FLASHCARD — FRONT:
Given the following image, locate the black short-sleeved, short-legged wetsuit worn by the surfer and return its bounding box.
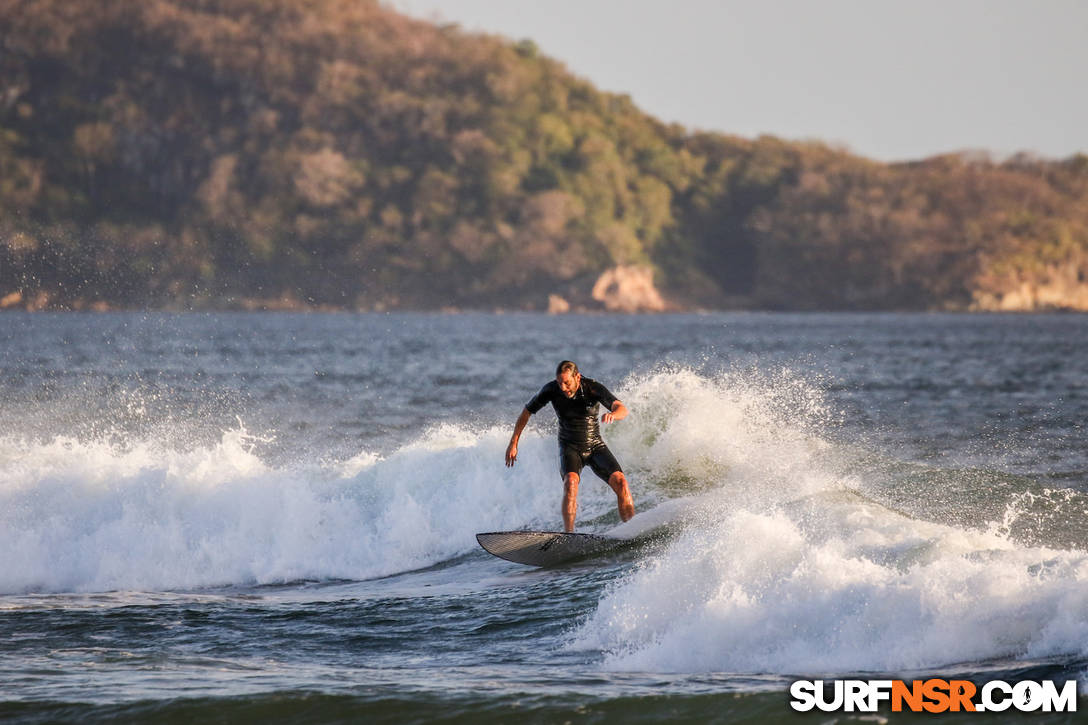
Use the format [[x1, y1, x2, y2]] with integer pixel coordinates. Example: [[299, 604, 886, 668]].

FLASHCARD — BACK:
[[526, 377, 623, 481]]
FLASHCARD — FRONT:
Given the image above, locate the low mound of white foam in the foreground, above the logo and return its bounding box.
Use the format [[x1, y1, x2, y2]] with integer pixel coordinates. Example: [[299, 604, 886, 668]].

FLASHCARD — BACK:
[[572, 474, 1088, 674]]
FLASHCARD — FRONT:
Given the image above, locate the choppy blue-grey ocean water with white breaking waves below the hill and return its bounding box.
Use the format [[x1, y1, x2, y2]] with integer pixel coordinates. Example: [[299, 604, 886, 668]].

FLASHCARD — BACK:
[[0, 312, 1088, 723]]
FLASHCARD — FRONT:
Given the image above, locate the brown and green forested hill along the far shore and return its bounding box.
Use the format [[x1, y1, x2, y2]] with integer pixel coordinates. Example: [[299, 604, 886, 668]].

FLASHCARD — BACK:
[[0, 0, 1088, 309]]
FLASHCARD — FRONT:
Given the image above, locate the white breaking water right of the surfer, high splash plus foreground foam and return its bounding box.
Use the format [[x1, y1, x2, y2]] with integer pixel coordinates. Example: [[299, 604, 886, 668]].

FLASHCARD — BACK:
[[569, 373, 1088, 675]]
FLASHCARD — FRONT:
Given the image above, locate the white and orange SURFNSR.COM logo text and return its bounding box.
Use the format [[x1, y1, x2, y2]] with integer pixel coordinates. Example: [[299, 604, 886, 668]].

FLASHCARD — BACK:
[[790, 679, 1077, 713]]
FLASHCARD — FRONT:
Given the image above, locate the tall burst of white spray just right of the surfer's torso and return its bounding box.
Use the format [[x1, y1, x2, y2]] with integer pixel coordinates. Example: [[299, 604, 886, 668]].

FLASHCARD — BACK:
[[607, 367, 844, 501]]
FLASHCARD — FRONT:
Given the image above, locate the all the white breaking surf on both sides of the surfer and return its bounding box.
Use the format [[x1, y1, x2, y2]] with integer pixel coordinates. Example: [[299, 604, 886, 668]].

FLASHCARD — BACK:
[[10, 354, 1088, 661]]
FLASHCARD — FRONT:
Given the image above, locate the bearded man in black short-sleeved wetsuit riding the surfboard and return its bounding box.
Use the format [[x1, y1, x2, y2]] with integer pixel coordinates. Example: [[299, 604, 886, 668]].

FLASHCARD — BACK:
[[506, 360, 634, 531]]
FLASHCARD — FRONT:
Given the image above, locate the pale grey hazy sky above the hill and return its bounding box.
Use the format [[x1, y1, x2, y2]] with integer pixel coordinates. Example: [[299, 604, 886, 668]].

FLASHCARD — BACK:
[[385, 0, 1088, 161]]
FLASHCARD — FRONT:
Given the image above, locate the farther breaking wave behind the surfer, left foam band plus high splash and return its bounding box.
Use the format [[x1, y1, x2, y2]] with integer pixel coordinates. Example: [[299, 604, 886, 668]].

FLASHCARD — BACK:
[[0, 369, 813, 593]]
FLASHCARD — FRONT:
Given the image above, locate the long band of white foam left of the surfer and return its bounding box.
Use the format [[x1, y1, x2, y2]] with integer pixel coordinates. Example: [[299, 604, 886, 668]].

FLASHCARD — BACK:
[[0, 418, 615, 593]]
